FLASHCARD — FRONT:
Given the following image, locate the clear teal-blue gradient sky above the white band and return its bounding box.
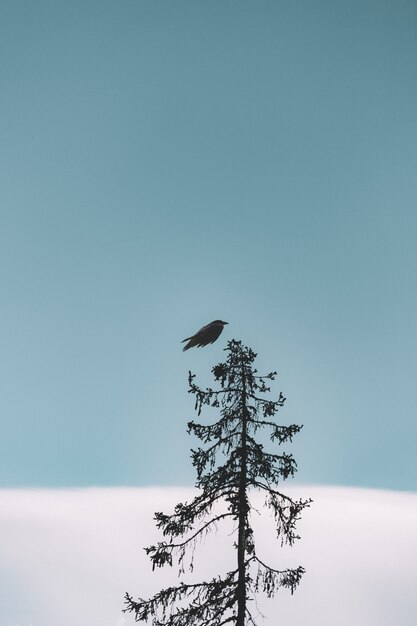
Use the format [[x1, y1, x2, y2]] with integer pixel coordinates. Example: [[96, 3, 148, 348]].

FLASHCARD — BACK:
[[0, 0, 417, 490]]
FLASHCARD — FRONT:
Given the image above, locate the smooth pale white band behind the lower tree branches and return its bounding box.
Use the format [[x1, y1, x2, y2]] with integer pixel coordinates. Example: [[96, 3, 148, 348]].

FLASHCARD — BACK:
[[0, 486, 417, 626]]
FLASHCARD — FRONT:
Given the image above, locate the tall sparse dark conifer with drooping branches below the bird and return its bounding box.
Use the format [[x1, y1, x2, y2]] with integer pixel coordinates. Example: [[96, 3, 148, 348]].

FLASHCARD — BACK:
[[125, 340, 311, 626]]
